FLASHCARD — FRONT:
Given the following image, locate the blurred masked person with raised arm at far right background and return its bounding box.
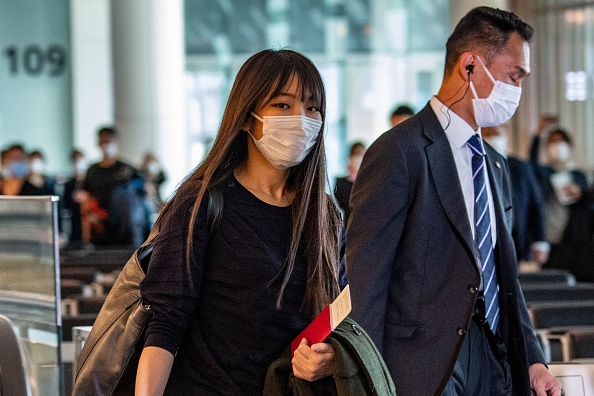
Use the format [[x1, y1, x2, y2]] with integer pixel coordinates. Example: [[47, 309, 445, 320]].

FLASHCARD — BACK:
[[530, 127, 594, 282]]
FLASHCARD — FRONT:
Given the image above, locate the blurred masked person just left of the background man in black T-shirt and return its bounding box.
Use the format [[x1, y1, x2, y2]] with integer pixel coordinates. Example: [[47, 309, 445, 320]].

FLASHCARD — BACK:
[[63, 149, 89, 248]]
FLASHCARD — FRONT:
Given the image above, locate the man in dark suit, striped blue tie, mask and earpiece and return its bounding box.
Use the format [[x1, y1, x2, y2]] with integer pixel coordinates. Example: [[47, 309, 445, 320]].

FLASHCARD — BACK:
[[347, 7, 560, 396]]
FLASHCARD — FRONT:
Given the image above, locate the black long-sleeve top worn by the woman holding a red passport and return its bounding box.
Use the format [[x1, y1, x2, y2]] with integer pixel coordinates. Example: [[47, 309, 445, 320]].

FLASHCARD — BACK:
[[141, 179, 346, 395]]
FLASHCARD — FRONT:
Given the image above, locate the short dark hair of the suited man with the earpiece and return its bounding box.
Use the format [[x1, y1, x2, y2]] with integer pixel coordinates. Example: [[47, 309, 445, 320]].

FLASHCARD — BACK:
[[445, 7, 534, 76]]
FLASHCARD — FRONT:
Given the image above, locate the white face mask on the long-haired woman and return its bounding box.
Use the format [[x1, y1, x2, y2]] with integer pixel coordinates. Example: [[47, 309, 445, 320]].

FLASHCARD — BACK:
[[248, 112, 322, 170]]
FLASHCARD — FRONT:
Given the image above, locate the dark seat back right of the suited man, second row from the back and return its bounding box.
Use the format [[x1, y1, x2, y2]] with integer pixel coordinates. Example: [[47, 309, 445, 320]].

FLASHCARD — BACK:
[[522, 283, 594, 305]]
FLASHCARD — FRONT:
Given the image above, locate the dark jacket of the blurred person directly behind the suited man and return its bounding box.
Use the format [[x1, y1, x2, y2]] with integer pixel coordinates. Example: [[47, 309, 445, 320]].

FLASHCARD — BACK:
[[507, 157, 547, 261]]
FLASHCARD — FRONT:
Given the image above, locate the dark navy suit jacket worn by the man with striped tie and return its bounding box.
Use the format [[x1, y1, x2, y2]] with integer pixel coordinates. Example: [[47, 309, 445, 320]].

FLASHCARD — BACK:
[[347, 105, 544, 396]]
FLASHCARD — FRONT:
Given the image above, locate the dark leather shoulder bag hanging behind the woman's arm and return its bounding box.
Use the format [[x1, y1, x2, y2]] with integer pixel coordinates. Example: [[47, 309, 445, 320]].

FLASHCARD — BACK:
[[72, 188, 223, 396]]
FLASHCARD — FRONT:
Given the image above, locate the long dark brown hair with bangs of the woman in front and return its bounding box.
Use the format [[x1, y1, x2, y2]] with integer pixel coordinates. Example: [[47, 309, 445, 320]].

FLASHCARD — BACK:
[[156, 49, 341, 318]]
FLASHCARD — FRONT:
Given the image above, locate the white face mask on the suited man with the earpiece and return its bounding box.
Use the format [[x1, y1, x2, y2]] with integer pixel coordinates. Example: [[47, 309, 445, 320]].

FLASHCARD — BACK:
[[470, 56, 522, 127]]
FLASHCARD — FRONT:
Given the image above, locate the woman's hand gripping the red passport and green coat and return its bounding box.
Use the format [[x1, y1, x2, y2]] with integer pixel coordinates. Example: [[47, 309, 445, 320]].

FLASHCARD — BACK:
[[292, 338, 334, 382]]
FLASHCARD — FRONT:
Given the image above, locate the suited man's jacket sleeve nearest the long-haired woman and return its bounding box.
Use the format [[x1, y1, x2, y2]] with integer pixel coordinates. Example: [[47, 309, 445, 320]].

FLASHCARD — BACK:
[[346, 132, 409, 351]]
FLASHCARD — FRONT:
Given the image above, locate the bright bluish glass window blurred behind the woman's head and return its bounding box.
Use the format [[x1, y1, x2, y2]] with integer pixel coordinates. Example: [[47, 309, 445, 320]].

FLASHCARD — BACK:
[[185, 0, 450, 180]]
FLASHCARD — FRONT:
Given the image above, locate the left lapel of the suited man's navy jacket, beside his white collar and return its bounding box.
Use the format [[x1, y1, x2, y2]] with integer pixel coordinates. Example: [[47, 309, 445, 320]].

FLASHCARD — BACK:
[[420, 106, 474, 251]]
